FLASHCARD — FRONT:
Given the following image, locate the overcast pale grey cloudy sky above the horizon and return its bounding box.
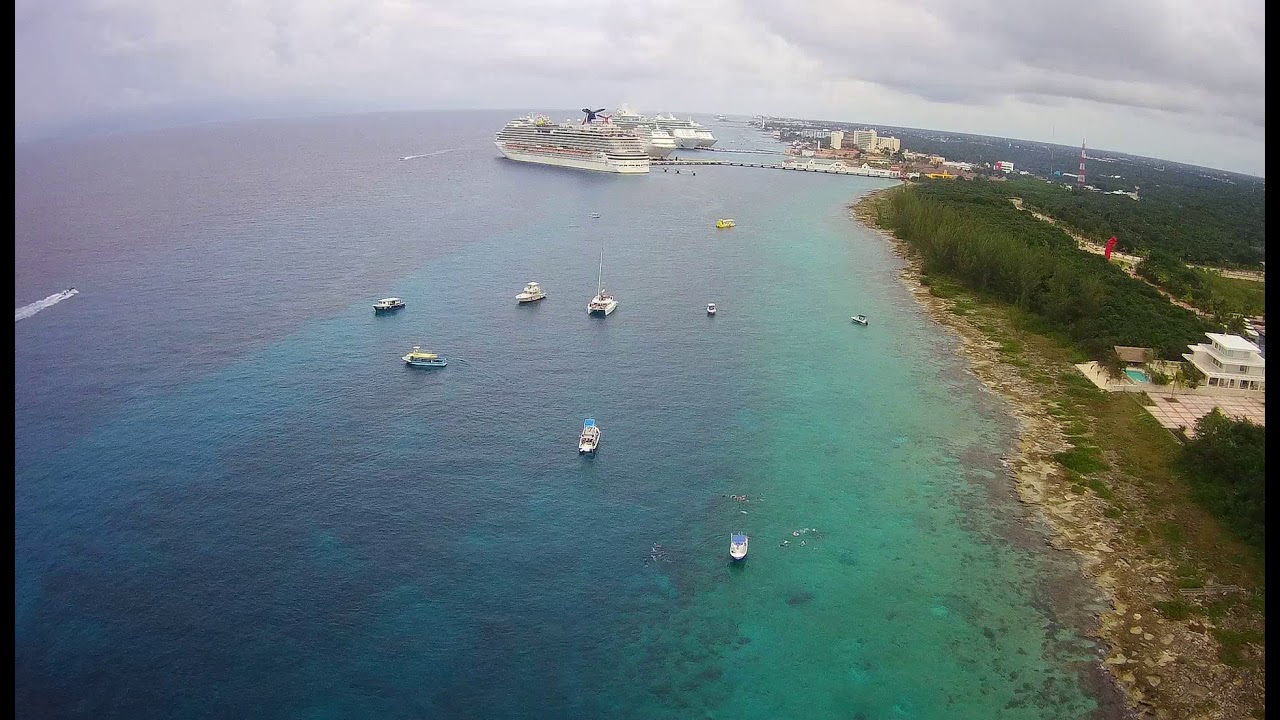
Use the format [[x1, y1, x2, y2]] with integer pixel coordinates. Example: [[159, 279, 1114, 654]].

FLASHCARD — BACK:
[[14, 0, 1266, 177]]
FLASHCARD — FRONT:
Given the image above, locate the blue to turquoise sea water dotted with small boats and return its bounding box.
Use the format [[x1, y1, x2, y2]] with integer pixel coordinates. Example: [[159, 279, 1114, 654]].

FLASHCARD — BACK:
[[14, 113, 1119, 720]]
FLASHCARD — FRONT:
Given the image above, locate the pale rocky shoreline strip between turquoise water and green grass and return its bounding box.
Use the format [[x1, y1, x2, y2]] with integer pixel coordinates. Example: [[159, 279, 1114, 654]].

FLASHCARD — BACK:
[[850, 188, 1265, 720]]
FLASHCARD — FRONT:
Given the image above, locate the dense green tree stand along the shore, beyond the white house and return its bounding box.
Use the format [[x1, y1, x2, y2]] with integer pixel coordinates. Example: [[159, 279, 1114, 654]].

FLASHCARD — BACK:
[[878, 181, 1220, 361]]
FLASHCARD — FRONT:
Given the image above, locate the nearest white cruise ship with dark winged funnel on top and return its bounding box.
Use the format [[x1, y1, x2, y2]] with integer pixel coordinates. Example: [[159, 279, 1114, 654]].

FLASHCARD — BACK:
[[494, 110, 649, 174]]
